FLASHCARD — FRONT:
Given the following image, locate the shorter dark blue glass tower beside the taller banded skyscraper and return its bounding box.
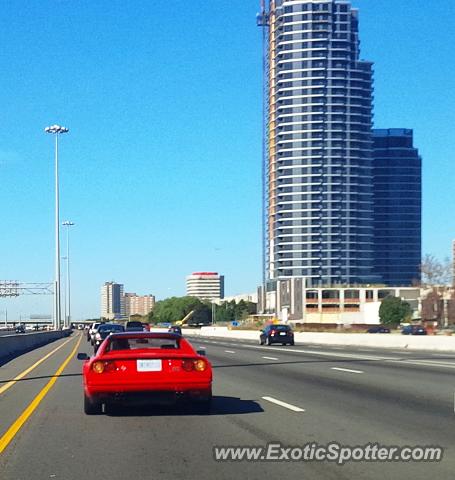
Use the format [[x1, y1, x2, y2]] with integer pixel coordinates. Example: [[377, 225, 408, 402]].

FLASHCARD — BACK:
[[373, 129, 422, 286]]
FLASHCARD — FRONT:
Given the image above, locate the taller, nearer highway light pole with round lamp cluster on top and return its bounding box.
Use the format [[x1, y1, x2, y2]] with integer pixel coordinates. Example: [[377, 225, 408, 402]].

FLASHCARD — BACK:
[[44, 125, 69, 330]]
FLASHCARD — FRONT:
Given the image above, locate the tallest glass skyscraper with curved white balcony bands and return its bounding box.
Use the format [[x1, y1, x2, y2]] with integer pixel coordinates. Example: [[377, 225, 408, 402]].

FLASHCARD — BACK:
[[258, 0, 380, 285]]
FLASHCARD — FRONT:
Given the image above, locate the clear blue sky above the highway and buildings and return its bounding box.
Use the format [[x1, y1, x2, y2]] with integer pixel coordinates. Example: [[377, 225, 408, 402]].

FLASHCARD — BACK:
[[0, 0, 455, 322]]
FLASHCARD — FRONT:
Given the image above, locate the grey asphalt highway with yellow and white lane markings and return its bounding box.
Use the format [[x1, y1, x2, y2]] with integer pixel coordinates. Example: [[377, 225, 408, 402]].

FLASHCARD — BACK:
[[0, 332, 455, 480]]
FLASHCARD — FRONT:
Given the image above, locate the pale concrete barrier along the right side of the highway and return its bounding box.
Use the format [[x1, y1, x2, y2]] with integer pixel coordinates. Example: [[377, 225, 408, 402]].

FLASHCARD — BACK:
[[183, 327, 455, 352]]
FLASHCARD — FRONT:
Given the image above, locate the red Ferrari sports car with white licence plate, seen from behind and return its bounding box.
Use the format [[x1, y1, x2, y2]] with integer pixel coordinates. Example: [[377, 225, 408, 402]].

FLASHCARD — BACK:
[[77, 332, 212, 415]]
